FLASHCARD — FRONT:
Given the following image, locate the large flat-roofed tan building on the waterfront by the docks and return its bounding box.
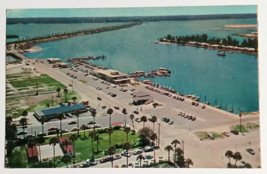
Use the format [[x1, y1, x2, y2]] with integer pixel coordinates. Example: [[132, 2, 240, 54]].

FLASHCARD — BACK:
[[91, 69, 131, 84]]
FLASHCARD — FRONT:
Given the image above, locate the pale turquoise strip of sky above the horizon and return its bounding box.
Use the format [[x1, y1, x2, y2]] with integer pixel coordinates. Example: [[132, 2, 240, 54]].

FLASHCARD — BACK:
[[6, 5, 257, 18]]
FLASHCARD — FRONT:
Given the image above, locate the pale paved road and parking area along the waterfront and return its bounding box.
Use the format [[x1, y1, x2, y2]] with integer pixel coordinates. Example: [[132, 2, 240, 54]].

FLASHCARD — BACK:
[[11, 52, 260, 168]]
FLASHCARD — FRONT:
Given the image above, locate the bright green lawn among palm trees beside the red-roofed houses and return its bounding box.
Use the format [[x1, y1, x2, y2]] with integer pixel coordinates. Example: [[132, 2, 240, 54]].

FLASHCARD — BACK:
[[45, 130, 138, 162]]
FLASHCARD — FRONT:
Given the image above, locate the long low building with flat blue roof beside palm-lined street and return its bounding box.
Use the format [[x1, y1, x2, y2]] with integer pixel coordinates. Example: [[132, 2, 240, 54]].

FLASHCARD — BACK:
[[33, 103, 87, 121]]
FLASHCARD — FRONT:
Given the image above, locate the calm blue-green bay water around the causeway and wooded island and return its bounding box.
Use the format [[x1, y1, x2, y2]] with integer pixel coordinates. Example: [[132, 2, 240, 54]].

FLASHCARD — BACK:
[[7, 19, 259, 113]]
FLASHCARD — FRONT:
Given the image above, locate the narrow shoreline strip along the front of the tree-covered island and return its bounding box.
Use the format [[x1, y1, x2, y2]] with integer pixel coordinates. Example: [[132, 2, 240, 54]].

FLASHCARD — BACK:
[[154, 41, 258, 56]]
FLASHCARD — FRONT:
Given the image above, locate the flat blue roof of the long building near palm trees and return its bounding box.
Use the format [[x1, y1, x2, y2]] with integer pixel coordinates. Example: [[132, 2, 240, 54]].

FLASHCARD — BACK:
[[34, 103, 86, 116]]
